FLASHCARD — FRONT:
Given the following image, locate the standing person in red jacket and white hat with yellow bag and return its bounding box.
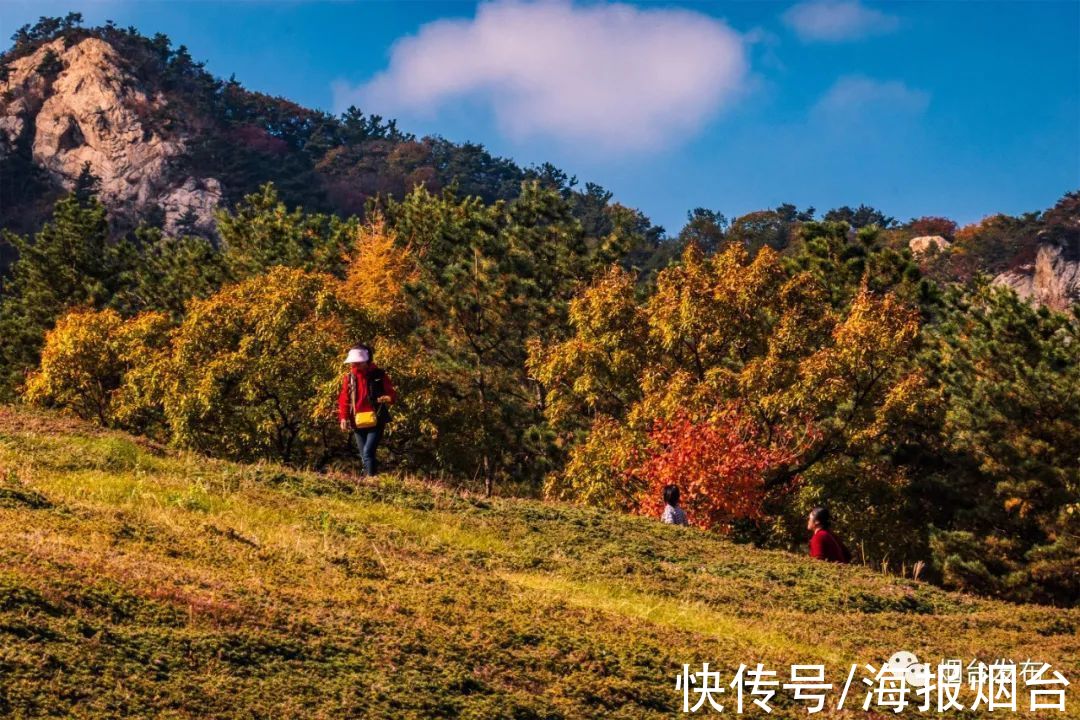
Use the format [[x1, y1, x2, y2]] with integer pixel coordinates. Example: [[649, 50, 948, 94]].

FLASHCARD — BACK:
[[338, 345, 397, 477]]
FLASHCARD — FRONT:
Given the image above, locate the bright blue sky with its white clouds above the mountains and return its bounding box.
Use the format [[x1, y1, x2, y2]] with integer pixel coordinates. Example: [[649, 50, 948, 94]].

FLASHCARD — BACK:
[[0, 0, 1080, 232]]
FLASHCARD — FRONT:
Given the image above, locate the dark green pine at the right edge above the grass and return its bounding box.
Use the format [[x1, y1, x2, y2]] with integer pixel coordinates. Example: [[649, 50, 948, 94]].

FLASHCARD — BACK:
[[927, 283, 1080, 603]]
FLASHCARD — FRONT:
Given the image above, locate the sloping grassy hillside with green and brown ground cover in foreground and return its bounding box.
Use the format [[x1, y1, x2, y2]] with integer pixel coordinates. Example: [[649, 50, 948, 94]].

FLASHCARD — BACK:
[[0, 408, 1080, 718]]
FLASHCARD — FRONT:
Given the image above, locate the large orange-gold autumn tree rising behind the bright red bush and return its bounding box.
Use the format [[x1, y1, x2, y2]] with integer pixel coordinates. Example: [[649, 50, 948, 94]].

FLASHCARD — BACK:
[[529, 235, 923, 557]]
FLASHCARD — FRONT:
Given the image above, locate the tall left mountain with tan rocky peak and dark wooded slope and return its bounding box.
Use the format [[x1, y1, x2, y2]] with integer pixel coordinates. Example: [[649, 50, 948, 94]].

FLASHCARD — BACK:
[[0, 15, 662, 245]]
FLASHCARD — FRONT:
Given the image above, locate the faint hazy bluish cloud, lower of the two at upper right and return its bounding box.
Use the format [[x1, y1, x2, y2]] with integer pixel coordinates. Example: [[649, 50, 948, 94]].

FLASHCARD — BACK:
[[810, 76, 930, 123]]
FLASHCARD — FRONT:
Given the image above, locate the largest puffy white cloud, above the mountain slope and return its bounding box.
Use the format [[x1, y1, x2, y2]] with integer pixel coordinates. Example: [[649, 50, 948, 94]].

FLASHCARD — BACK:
[[334, 0, 748, 150]]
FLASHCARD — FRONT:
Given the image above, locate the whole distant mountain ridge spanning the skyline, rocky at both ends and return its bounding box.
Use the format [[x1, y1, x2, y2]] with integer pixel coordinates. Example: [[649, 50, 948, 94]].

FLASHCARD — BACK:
[[0, 13, 1080, 309]]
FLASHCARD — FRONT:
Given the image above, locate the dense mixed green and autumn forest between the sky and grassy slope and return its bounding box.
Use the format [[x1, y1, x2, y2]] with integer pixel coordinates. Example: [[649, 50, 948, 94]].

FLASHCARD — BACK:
[[0, 17, 1080, 604]]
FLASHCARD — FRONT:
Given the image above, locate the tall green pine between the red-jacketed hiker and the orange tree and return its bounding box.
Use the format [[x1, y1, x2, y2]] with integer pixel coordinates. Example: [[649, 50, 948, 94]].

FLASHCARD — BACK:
[[387, 181, 635, 490]]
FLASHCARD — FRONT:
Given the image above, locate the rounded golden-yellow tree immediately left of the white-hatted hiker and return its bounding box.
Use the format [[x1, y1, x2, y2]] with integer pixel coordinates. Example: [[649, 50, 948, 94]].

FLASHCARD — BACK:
[[162, 268, 372, 464]]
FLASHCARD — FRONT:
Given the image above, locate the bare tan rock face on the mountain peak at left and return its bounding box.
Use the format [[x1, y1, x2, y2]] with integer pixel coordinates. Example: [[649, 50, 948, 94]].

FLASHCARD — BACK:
[[0, 37, 221, 234]]
